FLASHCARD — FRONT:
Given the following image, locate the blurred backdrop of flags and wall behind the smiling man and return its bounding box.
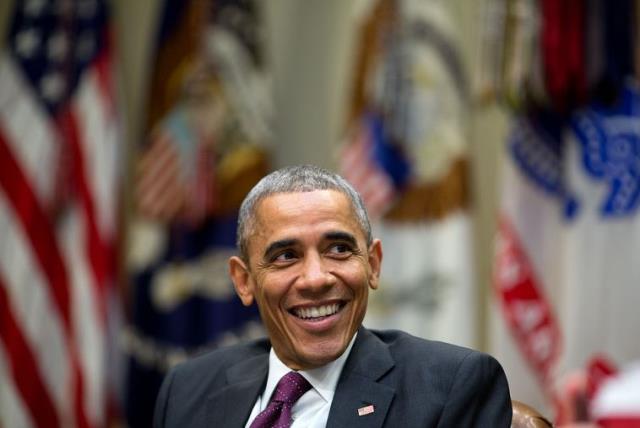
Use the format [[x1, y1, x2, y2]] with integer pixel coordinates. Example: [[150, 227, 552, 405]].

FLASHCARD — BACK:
[[0, 0, 640, 428]]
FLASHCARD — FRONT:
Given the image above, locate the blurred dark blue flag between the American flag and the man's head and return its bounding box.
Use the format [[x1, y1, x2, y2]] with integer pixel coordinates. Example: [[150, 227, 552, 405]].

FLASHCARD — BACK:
[[123, 0, 270, 427]]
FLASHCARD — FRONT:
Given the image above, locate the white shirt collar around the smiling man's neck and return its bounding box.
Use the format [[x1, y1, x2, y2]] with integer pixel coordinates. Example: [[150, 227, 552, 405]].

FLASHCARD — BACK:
[[262, 331, 358, 403]]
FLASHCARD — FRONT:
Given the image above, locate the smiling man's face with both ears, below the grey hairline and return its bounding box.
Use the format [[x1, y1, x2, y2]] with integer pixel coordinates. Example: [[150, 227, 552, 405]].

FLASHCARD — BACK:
[[229, 190, 382, 370]]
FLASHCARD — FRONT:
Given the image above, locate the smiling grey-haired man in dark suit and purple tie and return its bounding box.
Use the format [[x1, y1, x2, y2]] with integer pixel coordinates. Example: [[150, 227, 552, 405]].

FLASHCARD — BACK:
[[155, 166, 511, 428]]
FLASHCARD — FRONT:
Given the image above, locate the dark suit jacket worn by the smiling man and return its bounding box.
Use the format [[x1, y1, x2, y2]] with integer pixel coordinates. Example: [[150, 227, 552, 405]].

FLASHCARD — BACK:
[[154, 328, 511, 428]]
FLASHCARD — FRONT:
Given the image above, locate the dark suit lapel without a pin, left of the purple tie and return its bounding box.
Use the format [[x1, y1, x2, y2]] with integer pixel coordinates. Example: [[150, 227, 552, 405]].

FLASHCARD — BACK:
[[207, 353, 269, 427]]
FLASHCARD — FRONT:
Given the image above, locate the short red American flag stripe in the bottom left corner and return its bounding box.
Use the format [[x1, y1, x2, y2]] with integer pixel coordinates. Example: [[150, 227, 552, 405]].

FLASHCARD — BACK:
[[0, 278, 60, 427]]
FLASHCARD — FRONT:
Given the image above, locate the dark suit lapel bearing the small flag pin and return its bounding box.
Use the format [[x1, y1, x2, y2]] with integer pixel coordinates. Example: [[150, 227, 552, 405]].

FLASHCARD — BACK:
[[327, 328, 395, 428]]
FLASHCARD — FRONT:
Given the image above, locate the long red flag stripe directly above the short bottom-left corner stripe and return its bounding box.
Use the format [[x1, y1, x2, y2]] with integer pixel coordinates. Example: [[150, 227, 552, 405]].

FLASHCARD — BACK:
[[0, 132, 89, 428]]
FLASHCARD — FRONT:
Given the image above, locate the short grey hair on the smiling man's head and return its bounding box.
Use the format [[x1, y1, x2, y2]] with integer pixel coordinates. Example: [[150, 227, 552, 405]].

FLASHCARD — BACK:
[[236, 165, 373, 261]]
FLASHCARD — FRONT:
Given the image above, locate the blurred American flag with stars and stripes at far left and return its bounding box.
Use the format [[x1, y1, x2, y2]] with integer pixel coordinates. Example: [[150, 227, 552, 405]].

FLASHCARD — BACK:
[[0, 0, 119, 427]]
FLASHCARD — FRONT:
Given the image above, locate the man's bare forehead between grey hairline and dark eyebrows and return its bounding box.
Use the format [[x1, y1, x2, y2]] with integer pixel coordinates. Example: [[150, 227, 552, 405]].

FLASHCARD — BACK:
[[254, 190, 364, 238]]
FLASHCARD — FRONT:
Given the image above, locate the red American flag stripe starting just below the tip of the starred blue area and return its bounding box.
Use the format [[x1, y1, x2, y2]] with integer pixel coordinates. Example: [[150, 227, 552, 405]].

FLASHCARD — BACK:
[[58, 109, 110, 328]]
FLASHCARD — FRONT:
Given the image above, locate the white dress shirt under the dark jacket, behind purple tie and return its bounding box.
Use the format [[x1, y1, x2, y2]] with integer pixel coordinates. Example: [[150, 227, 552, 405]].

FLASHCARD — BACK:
[[245, 332, 358, 428]]
